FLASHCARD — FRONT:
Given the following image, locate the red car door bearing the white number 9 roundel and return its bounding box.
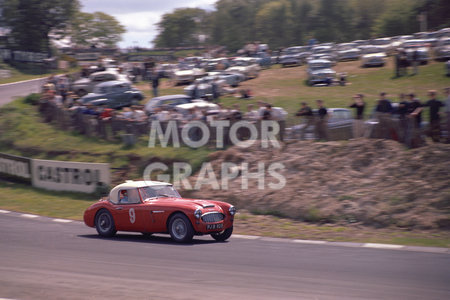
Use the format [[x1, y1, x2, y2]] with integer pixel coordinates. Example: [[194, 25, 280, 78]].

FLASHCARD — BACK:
[[114, 188, 151, 232]]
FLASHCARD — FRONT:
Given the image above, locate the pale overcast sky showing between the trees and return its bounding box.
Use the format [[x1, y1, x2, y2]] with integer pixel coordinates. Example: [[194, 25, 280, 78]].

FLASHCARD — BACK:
[[80, 0, 217, 48]]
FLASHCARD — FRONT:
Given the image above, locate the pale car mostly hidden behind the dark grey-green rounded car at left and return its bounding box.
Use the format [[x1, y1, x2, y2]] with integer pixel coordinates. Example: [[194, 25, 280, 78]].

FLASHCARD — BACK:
[[71, 71, 131, 97]]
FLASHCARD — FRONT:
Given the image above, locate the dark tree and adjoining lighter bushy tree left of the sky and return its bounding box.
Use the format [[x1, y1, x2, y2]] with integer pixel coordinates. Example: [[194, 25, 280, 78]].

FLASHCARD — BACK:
[[0, 0, 125, 54]]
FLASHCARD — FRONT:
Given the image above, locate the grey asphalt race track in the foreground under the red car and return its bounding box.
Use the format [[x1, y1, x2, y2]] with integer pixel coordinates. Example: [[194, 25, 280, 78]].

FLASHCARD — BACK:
[[0, 211, 450, 299]]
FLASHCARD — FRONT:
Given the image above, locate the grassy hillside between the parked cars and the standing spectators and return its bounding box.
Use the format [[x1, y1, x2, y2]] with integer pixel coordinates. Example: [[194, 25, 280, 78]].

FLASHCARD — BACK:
[[139, 58, 450, 123]]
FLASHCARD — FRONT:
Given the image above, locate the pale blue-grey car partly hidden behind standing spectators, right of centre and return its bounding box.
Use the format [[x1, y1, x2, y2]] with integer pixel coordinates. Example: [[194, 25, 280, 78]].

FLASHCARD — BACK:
[[286, 108, 354, 140]]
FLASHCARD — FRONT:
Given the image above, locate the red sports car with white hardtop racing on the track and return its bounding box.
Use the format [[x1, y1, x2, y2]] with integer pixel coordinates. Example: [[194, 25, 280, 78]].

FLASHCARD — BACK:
[[84, 180, 236, 242]]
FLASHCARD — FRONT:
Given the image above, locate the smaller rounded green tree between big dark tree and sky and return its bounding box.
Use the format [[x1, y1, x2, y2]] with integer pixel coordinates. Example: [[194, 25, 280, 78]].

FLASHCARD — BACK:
[[69, 12, 125, 47]]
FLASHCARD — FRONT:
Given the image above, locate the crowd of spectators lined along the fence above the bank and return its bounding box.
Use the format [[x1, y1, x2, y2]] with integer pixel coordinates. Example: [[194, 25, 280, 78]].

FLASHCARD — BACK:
[[40, 69, 450, 148]]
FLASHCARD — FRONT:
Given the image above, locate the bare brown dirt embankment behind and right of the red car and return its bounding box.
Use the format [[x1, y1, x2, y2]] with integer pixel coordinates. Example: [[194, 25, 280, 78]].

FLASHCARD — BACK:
[[185, 139, 450, 230]]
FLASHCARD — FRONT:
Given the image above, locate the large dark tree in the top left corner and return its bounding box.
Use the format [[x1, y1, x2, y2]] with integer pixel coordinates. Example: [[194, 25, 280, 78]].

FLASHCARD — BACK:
[[2, 0, 80, 52]]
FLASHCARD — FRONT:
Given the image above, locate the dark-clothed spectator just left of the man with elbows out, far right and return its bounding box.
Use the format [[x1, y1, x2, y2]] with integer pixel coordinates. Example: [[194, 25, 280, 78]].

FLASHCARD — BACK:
[[405, 93, 423, 148]]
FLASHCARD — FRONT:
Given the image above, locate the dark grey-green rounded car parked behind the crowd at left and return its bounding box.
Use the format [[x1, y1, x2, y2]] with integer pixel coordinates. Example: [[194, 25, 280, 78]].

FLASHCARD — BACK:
[[80, 80, 144, 108]]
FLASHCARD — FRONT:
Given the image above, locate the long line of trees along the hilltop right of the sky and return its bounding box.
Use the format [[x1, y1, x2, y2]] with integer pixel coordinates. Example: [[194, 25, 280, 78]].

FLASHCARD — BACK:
[[153, 0, 450, 51]]
